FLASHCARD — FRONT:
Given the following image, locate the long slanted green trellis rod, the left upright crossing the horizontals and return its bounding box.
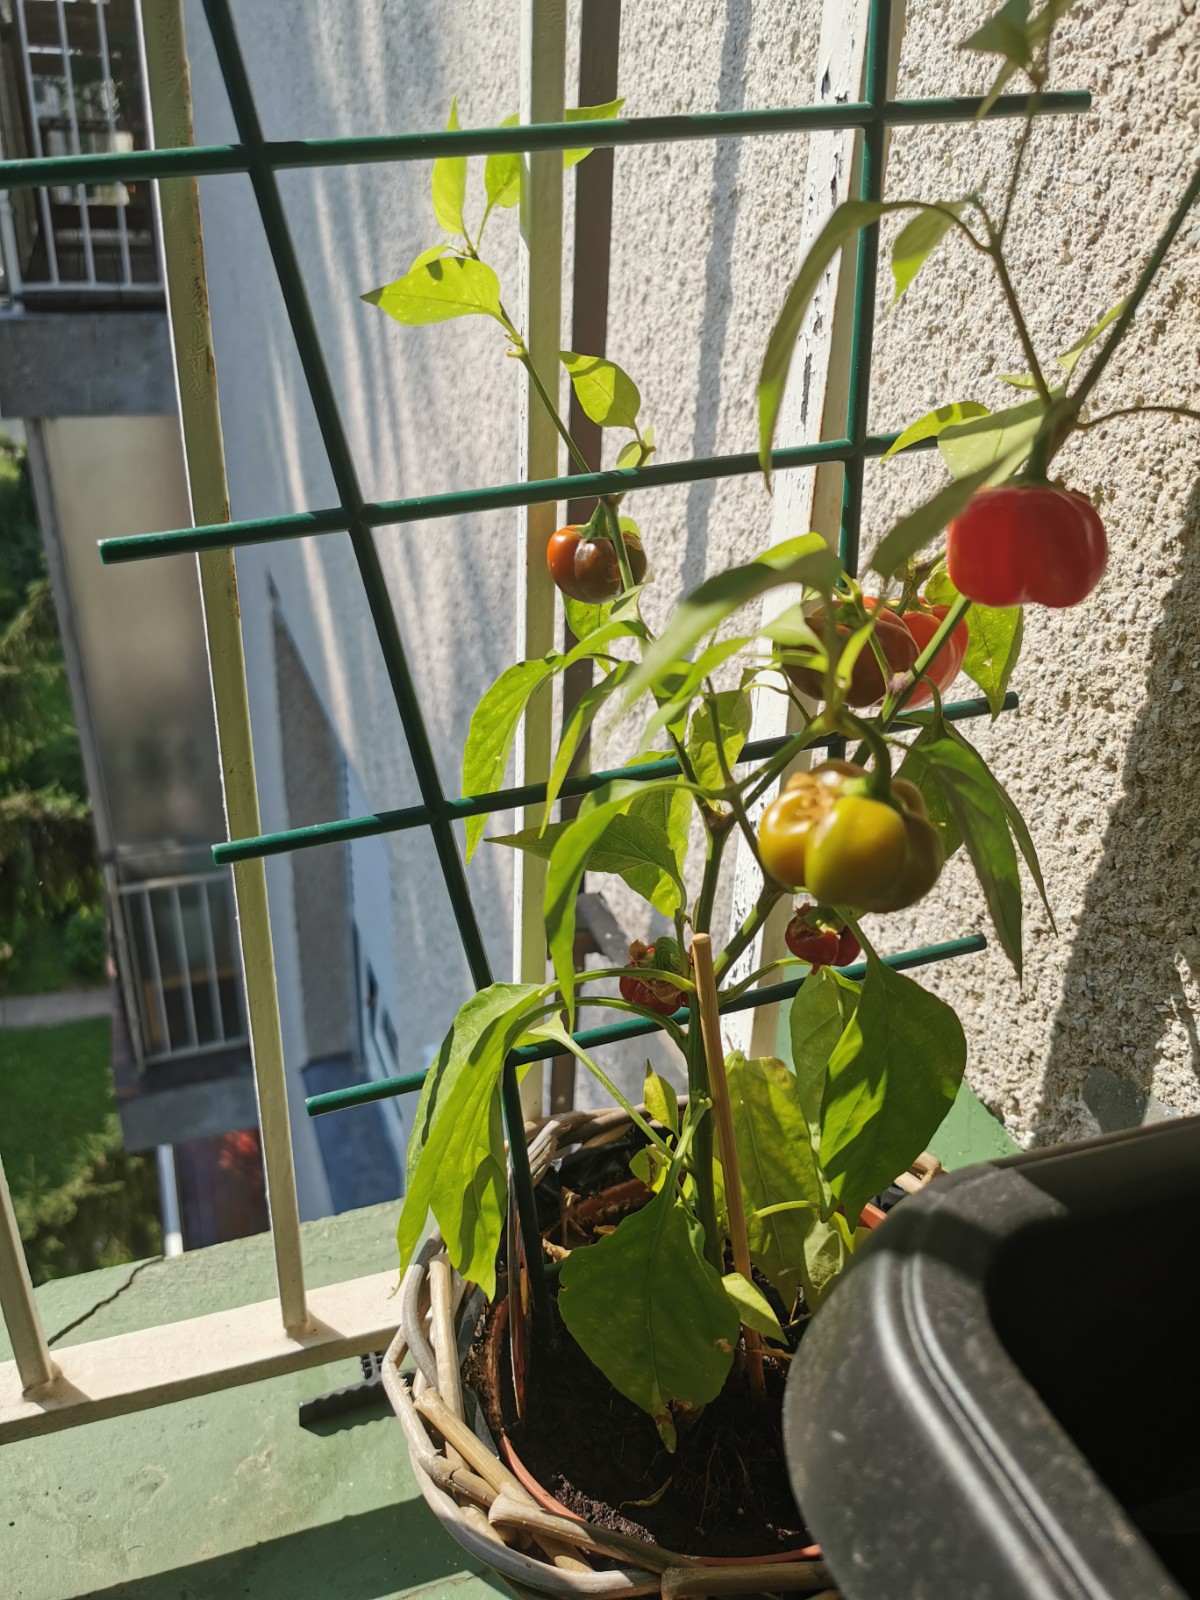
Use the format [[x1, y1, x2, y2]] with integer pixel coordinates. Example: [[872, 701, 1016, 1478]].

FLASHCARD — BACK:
[[203, 0, 491, 989]]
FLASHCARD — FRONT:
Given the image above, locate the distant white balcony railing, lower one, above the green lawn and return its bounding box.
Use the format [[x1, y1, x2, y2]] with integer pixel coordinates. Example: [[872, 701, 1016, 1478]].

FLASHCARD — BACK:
[[117, 872, 248, 1066]]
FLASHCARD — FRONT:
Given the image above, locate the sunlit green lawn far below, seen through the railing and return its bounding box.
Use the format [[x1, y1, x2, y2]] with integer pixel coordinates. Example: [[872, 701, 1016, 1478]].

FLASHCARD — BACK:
[[0, 1018, 162, 1283]]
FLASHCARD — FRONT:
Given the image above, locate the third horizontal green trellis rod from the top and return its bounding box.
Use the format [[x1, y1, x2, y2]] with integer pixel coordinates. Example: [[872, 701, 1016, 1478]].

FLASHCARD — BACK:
[[213, 690, 1019, 867]]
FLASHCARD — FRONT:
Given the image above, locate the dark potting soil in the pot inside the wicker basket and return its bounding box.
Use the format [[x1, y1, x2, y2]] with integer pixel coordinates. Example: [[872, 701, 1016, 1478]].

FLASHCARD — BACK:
[[502, 1306, 811, 1557]]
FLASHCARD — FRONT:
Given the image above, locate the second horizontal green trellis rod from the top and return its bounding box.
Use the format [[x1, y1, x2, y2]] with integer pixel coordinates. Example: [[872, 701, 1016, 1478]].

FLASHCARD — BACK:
[[99, 432, 938, 566]]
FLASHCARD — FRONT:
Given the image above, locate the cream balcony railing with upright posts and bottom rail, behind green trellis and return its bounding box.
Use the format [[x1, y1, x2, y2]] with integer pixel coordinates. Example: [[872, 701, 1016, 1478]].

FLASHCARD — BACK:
[[0, 0, 883, 1443]]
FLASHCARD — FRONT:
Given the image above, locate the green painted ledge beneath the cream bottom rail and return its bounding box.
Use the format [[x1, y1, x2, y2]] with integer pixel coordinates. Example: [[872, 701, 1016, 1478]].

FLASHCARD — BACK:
[[0, 1205, 507, 1600]]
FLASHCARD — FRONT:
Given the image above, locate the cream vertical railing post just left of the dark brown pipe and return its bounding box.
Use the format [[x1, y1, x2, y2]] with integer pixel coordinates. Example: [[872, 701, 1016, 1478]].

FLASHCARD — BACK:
[[512, 0, 566, 1117]]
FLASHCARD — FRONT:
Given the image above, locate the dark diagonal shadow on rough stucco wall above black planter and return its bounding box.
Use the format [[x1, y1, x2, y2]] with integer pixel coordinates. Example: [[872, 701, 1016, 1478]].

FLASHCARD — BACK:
[[1035, 467, 1200, 1144]]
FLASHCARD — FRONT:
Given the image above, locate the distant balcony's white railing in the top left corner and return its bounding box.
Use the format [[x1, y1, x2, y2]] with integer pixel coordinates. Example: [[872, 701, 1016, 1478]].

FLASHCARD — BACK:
[[0, 0, 163, 310]]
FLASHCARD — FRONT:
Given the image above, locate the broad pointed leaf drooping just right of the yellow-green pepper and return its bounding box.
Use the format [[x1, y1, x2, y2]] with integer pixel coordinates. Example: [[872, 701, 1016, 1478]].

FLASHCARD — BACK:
[[906, 736, 1021, 978]]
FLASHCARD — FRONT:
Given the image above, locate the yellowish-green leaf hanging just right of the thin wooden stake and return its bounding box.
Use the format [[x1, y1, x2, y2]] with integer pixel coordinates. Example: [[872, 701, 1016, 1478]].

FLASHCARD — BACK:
[[726, 1051, 824, 1306]]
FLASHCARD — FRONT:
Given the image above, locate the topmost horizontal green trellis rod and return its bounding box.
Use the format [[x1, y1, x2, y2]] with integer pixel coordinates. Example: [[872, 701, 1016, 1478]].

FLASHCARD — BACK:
[[0, 90, 1091, 189]]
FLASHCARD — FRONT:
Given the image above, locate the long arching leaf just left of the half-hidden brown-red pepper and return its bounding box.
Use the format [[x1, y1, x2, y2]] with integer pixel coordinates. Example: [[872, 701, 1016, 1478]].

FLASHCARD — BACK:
[[626, 533, 842, 707]]
